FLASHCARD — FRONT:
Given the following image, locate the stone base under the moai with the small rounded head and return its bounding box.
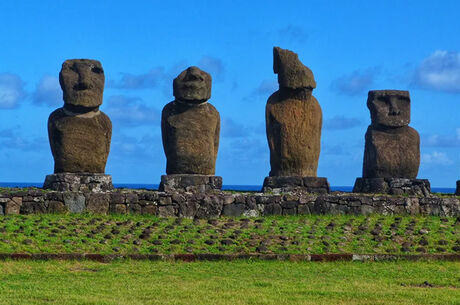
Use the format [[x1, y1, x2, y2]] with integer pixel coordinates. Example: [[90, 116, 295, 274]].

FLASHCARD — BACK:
[[159, 174, 222, 193]]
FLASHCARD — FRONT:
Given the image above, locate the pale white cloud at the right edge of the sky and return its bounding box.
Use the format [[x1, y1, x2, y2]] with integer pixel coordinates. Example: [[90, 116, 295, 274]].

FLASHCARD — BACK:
[[413, 50, 460, 93]]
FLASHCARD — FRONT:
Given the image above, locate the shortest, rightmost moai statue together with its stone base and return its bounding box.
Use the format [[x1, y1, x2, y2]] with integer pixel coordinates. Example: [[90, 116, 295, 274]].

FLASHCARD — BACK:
[[353, 90, 430, 195]]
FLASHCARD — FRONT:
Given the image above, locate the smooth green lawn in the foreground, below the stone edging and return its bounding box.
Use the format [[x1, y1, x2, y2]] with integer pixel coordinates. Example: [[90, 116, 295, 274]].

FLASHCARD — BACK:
[[0, 260, 460, 305]]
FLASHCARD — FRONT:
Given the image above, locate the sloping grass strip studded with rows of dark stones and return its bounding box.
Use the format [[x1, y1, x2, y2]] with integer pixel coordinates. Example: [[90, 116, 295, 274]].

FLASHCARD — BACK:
[[0, 214, 460, 254]]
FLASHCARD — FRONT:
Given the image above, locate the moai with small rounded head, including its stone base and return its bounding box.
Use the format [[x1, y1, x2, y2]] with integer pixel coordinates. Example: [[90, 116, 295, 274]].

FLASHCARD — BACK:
[[160, 67, 222, 192]]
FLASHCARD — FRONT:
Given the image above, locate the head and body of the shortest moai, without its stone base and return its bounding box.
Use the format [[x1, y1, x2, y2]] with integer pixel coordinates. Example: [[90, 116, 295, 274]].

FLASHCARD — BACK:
[[363, 90, 420, 179]]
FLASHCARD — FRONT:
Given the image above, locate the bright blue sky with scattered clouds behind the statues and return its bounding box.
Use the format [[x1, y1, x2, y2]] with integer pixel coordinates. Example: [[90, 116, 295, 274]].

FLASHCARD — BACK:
[[0, 0, 460, 187]]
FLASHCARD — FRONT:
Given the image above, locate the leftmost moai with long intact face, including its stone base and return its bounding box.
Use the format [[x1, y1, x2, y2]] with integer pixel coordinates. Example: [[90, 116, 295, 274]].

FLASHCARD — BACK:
[[44, 59, 113, 192]]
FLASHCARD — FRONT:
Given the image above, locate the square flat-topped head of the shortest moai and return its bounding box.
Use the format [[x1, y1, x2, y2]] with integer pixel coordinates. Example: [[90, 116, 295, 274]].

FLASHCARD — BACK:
[[367, 90, 410, 127]]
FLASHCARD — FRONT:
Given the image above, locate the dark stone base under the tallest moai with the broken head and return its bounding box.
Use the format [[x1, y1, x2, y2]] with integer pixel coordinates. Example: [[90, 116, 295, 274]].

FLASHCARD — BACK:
[[262, 176, 330, 194]]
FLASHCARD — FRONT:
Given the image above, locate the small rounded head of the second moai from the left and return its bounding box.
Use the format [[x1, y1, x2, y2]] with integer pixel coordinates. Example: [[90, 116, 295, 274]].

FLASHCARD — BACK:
[[173, 67, 212, 104]]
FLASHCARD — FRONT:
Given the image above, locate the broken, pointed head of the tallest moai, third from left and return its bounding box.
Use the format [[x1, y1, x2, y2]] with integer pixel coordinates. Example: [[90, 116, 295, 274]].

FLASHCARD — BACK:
[[273, 47, 316, 90]]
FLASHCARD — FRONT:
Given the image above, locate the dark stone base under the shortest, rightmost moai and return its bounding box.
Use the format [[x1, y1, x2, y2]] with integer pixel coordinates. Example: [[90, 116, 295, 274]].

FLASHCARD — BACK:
[[353, 178, 431, 196]]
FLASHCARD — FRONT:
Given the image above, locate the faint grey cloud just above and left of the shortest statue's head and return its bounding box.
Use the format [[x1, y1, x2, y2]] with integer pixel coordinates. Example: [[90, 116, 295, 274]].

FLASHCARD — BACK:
[[330, 68, 380, 96]]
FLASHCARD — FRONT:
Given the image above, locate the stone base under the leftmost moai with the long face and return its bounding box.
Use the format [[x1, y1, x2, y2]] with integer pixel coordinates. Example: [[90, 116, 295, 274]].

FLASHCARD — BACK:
[[43, 173, 113, 193]]
